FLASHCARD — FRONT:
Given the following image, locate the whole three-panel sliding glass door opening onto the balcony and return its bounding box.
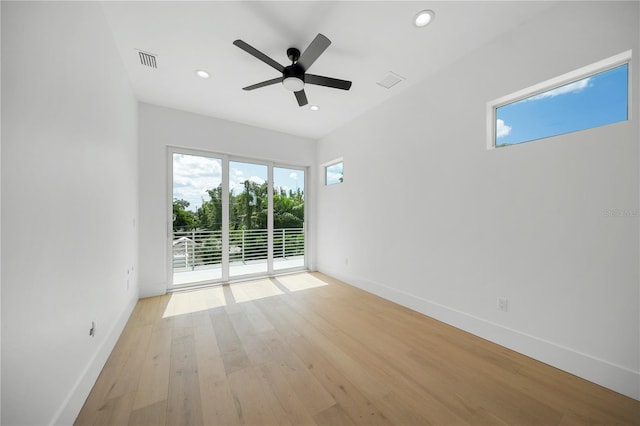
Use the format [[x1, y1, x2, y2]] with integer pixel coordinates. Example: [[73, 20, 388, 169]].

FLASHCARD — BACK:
[[169, 149, 306, 288]]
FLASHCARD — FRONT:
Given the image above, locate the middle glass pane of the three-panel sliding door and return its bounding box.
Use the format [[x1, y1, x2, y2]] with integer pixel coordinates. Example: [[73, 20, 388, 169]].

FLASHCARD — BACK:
[[229, 161, 269, 277]]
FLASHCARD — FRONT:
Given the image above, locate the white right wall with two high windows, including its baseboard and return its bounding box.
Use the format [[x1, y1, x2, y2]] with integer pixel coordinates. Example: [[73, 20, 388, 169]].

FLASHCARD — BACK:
[[317, 2, 640, 398]]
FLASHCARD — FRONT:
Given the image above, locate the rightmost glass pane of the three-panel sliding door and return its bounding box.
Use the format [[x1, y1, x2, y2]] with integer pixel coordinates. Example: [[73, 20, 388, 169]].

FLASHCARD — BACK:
[[273, 167, 304, 270]]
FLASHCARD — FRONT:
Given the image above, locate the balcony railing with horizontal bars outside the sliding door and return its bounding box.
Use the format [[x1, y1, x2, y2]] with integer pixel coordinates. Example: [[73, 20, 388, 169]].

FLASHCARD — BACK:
[[173, 228, 304, 269]]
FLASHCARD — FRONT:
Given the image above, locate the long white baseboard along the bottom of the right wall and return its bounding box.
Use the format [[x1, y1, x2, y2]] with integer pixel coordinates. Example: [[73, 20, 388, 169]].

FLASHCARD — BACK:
[[318, 265, 640, 400]]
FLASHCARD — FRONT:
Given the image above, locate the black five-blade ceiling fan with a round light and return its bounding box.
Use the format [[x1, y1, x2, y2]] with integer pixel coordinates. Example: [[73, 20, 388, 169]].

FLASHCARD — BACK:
[[233, 34, 351, 106]]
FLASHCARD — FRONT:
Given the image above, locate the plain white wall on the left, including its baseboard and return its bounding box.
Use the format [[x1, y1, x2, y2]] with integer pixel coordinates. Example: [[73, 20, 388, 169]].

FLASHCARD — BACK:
[[1, 1, 138, 425]]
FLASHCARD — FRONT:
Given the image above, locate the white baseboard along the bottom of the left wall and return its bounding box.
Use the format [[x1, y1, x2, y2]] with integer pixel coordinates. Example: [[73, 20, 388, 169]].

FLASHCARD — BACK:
[[50, 299, 138, 426]]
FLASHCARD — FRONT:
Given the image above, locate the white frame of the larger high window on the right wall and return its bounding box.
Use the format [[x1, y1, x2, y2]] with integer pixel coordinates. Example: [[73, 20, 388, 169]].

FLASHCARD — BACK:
[[486, 50, 633, 150]]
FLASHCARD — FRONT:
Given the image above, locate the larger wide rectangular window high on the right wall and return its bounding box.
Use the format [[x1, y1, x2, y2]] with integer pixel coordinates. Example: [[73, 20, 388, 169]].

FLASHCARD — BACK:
[[488, 51, 631, 148]]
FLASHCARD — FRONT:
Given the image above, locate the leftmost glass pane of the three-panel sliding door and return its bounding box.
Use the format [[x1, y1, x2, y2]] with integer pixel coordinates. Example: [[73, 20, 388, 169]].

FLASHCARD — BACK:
[[172, 153, 222, 285]]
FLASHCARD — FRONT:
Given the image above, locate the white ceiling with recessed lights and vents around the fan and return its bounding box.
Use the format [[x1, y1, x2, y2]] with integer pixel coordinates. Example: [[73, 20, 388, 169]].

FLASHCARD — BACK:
[[103, 1, 553, 139]]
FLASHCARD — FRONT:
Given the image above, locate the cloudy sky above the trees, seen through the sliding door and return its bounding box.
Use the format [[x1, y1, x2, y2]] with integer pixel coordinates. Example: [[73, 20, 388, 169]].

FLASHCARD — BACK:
[[173, 154, 304, 212]]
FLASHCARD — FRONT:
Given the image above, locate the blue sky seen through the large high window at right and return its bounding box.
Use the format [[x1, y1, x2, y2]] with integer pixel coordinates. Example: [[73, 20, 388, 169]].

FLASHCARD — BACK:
[[496, 64, 628, 146]]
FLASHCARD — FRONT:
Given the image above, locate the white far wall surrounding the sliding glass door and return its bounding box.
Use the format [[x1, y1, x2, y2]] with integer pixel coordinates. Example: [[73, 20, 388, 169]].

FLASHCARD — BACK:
[[139, 103, 317, 297]]
